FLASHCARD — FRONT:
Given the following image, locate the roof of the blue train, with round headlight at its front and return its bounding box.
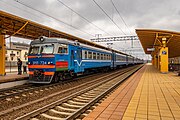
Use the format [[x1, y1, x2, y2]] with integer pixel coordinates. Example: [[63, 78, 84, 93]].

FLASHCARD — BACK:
[[31, 37, 130, 56]]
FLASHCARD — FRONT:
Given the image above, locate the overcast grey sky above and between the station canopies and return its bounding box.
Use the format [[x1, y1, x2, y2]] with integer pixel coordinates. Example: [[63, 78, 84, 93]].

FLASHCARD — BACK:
[[0, 0, 180, 59]]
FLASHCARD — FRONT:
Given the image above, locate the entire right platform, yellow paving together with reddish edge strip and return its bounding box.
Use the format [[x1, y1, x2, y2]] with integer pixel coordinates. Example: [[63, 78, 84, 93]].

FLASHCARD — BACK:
[[83, 64, 180, 120]]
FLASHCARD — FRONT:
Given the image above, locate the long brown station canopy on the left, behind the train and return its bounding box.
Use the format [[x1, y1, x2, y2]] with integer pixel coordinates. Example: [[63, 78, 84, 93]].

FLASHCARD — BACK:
[[0, 10, 127, 55]]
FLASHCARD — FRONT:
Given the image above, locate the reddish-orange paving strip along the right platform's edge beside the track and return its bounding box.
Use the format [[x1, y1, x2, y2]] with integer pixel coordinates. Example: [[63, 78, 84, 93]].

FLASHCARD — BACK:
[[83, 66, 146, 120]]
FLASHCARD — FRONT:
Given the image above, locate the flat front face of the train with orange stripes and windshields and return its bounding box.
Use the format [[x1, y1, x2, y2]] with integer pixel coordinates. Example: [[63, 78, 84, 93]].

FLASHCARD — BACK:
[[28, 44, 55, 83]]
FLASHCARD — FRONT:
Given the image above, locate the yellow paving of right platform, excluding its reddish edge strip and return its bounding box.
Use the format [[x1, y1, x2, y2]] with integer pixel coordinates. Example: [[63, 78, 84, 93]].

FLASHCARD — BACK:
[[123, 65, 180, 120]]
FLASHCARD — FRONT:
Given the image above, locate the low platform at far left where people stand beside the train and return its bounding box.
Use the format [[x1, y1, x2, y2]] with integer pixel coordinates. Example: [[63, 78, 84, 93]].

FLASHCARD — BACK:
[[0, 72, 28, 84]]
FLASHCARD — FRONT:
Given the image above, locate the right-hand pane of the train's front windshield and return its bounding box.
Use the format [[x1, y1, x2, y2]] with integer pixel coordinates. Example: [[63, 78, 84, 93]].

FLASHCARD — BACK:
[[40, 44, 54, 54]]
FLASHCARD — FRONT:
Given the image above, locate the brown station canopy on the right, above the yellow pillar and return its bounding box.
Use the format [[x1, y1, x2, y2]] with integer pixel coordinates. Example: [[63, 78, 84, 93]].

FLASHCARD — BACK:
[[136, 29, 180, 58]]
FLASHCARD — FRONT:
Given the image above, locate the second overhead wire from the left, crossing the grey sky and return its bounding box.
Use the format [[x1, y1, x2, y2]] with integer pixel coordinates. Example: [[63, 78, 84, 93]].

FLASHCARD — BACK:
[[57, 0, 112, 36]]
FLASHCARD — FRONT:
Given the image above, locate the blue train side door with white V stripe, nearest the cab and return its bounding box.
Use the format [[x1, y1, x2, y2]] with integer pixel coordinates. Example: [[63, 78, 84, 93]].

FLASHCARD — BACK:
[[74, 47, 82, 72]]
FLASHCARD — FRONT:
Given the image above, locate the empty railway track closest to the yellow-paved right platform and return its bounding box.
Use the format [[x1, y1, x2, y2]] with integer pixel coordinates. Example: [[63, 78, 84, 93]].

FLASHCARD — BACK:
[[16, 66, 142, 120]]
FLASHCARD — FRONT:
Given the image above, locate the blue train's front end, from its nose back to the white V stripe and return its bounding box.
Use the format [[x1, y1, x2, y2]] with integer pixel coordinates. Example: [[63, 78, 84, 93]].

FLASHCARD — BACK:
[[28, 39, 83, 84]]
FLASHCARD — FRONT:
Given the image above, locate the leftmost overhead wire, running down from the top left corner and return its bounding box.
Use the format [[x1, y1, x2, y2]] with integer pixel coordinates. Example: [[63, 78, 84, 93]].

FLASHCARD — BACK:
[[14, 0, 94, 37]]
